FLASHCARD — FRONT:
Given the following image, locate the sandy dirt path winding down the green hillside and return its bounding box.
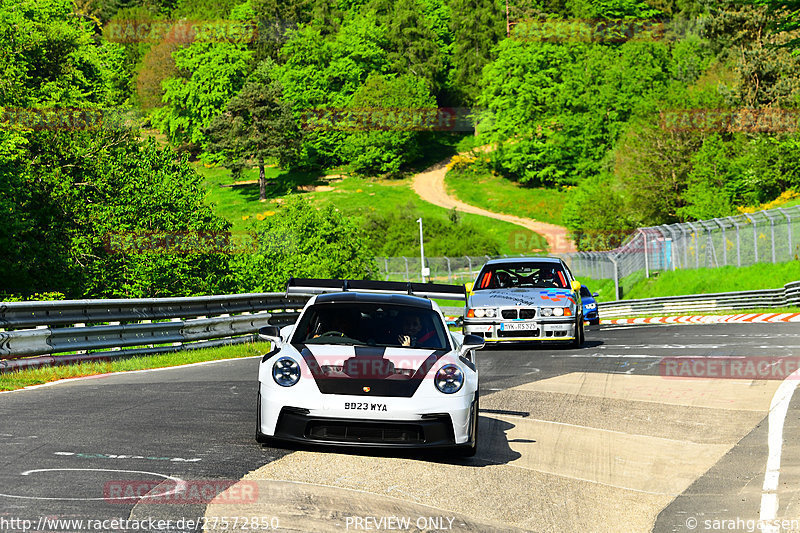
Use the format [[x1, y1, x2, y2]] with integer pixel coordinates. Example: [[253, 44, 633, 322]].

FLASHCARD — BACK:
[[412, 159, 577, 254]]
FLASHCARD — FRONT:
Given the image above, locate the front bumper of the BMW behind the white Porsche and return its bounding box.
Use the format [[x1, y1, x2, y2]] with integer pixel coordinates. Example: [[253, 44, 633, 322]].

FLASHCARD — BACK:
[[464, 318, 576, 343]]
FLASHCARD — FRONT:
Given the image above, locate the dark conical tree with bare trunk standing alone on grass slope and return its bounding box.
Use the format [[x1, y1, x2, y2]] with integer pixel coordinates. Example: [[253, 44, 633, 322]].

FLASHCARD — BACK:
[[208, 62, 300, 200]]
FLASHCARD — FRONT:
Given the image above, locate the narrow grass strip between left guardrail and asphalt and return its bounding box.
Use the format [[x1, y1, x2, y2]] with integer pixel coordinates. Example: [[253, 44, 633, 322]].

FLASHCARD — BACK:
[[0, 342, 269, 390]]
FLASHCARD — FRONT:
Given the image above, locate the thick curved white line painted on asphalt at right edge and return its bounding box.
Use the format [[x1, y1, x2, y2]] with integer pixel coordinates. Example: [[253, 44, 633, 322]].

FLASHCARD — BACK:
[[759, 370, 800, 533]]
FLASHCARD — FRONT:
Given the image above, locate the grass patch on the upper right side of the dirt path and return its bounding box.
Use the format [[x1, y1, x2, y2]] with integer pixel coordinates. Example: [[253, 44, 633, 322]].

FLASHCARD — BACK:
[[445, 170, 568, 225]]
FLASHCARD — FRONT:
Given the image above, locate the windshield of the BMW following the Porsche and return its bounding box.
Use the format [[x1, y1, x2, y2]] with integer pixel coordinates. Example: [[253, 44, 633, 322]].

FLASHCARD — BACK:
[[473, 263, 569, 291]]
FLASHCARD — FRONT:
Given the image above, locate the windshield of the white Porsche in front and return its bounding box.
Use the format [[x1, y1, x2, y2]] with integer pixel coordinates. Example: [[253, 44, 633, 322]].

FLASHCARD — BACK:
[[292, 302, 449, 350]]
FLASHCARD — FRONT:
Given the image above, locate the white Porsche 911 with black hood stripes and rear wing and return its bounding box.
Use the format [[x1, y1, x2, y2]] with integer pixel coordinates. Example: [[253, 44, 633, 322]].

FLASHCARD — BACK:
[[256, 279, 484, 456]]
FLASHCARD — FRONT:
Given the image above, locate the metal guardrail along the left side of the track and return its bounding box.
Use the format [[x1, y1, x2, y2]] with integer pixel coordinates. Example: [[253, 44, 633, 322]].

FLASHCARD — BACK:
[[0, 293, 309, 372]]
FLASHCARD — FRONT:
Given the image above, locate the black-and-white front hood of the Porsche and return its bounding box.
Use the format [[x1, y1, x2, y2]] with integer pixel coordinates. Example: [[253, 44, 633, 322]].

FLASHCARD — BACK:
[[293, 344, 450, 398]]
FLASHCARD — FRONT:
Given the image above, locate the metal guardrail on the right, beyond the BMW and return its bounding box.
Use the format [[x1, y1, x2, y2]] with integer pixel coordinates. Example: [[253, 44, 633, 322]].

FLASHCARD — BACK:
[[597, 281, 800, 318]]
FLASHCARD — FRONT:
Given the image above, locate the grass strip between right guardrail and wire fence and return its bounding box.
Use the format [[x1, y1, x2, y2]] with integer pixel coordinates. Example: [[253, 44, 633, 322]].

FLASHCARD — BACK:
[[580, 261, 800, 302]]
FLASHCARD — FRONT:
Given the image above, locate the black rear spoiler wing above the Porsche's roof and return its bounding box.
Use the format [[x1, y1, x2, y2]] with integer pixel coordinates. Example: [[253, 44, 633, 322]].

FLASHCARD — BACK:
[[286, 278, 467, 301]]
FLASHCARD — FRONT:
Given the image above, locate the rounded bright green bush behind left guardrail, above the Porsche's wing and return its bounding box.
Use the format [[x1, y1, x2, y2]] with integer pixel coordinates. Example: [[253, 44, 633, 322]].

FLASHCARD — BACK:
[[233, 197, 376, 292]]
